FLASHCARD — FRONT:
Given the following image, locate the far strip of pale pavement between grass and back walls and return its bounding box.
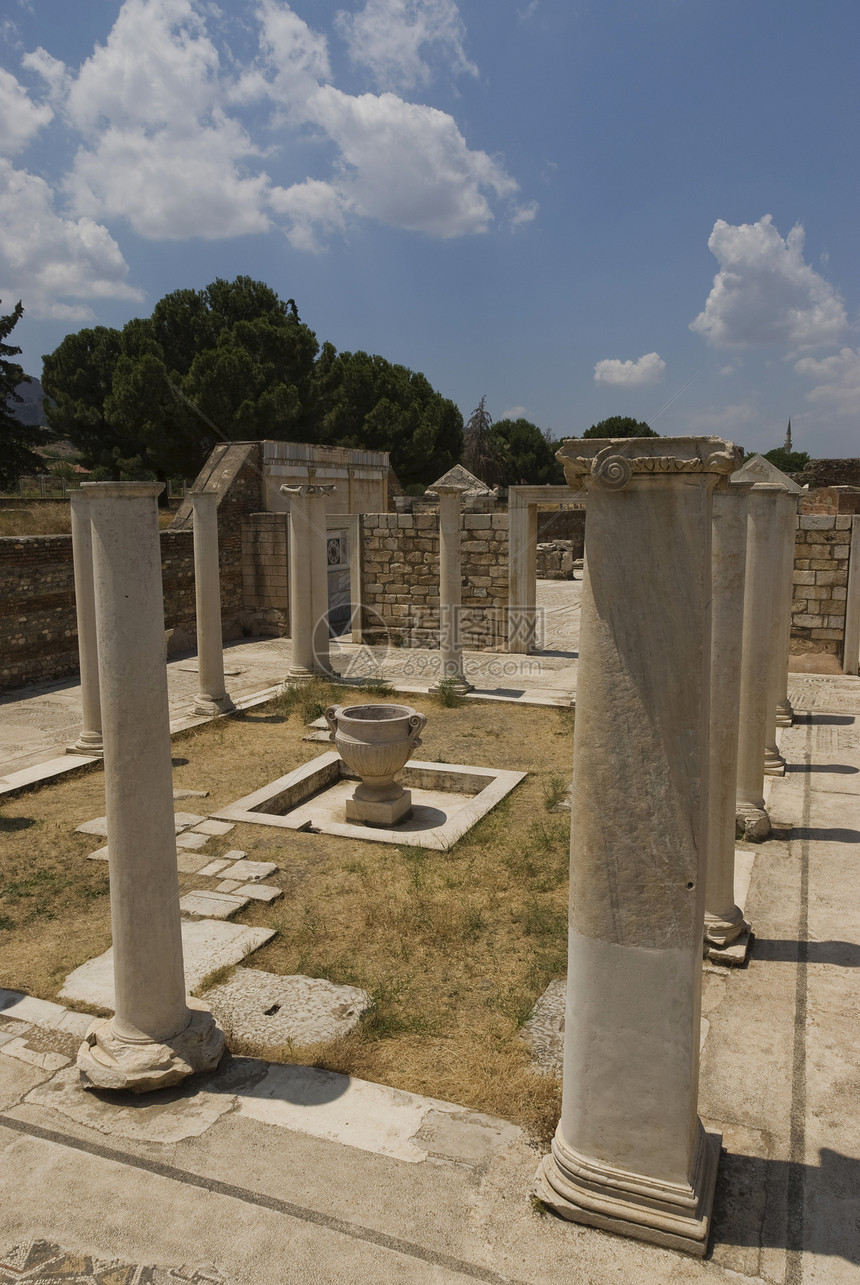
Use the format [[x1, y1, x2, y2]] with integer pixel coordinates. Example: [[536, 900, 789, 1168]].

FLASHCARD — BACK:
[[0, 580, 582, 794]]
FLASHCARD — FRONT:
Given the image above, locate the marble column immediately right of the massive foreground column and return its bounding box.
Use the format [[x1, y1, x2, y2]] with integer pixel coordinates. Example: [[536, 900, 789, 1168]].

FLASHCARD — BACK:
[[704, 482, 752, 950]]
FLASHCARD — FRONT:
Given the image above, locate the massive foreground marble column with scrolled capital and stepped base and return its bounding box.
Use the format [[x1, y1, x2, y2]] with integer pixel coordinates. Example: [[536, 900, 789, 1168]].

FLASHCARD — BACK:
[[536, 437, 740, 1255]]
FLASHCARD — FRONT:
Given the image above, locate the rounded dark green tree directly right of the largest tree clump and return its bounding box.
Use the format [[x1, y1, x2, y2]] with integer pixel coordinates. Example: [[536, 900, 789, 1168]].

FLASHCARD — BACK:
[[312, 343, 463, 486]]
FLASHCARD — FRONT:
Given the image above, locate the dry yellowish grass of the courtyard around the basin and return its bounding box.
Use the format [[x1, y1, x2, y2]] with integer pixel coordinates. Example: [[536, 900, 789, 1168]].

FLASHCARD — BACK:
[[0, 686, 573, 1139]]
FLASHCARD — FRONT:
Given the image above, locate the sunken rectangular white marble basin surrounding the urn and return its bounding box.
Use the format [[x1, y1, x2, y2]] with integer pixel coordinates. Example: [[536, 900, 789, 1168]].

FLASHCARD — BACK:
[[212, 750, 526, 851]]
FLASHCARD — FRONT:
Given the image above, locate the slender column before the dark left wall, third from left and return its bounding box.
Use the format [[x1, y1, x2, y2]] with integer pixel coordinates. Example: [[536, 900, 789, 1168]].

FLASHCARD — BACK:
[[189, 491, 235, 714]]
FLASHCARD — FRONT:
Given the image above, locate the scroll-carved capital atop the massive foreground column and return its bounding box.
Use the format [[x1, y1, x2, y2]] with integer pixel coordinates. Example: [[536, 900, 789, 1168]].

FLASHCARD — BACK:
[[555, 437, 742, 491]]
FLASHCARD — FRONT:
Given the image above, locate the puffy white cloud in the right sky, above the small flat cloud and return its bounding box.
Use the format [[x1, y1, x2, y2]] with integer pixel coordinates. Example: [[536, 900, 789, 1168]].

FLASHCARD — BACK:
[[690, 215, 847, 348]]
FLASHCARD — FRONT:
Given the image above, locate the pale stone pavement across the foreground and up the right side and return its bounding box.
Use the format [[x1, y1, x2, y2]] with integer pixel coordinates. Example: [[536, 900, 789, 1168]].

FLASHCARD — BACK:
[[0, 675, 860, 1285]]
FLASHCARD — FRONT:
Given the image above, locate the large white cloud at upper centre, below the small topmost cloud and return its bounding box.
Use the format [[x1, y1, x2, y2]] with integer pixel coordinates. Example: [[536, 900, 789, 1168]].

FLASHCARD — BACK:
[[309, 85, 518, 236]]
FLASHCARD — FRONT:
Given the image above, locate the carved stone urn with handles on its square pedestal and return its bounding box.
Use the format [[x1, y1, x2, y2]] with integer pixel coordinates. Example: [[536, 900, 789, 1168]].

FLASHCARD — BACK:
[[325, 705, 427, 826]]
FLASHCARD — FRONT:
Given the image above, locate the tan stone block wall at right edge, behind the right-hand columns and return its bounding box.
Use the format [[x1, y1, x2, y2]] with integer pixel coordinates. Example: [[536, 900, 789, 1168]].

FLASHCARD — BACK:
[[792, 513, 852, 659]]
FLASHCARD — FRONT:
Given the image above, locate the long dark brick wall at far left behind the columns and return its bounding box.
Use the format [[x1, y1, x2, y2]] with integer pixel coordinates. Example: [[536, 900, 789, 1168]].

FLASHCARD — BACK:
[[0, 531, 195, 691]]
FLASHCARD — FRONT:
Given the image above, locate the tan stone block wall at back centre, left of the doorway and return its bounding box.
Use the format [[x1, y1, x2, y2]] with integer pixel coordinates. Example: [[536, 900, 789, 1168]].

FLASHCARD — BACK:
[[361, 513, 508, 650]]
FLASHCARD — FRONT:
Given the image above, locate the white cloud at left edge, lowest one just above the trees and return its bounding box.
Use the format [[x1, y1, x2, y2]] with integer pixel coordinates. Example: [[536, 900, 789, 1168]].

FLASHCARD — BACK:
[[0, 159, 143, 321]]
